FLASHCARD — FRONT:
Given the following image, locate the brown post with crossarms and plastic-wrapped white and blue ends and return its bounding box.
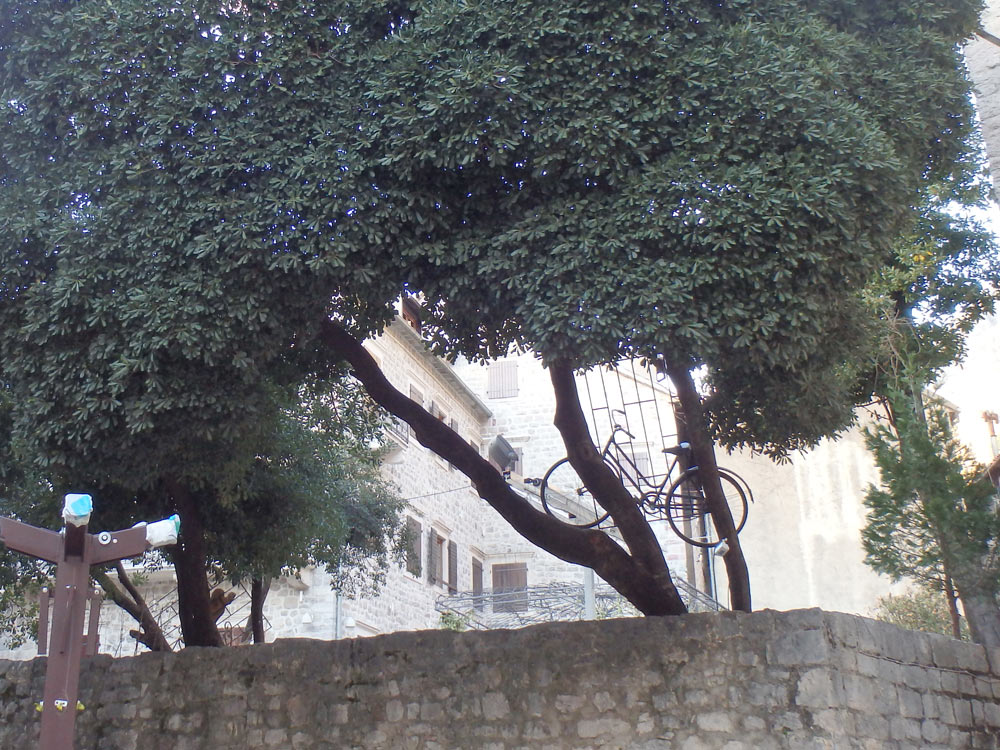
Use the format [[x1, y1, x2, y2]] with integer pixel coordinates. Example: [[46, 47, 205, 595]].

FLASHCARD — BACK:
[[0, 494, 180, 750]]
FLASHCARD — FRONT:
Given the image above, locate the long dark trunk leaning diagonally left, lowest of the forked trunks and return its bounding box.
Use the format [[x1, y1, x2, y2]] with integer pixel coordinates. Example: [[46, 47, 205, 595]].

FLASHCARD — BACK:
[[320, 320, 686, 615]]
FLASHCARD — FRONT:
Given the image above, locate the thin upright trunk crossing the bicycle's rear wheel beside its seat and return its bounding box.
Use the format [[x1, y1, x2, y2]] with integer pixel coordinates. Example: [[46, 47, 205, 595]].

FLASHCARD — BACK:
[[664, 352, 751, 612]]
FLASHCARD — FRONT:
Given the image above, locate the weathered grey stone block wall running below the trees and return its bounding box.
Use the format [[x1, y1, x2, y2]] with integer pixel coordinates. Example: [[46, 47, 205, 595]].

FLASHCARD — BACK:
[[0, 610, 1000, 750]]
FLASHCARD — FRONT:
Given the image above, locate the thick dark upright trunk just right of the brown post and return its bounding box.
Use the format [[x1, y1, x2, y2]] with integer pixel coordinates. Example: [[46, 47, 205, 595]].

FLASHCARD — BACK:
[[166, 480, 223, 647]]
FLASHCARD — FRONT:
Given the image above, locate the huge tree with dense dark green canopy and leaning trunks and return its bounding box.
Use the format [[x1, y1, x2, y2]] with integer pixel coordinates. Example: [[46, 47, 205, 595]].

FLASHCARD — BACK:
[[0, 0, 980, 632]]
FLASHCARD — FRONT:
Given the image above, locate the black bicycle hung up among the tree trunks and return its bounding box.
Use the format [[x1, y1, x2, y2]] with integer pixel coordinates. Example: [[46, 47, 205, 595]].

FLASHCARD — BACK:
[[534, 424, 753, 547]]
